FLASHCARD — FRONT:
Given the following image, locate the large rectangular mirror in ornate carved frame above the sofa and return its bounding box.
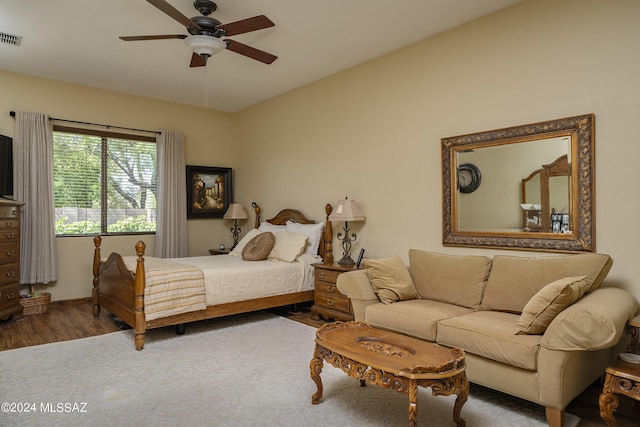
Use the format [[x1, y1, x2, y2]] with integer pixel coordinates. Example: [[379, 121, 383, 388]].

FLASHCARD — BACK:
[[441, 114, 595, 252]]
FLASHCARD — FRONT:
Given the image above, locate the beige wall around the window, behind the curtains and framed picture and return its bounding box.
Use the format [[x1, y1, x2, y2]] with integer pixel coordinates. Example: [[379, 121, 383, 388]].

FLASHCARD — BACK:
[[0, 71, 234, 300]]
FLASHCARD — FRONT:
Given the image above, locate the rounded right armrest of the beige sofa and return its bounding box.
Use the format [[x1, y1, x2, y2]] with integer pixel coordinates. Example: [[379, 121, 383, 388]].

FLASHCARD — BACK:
[[540, 287, 639, 351]]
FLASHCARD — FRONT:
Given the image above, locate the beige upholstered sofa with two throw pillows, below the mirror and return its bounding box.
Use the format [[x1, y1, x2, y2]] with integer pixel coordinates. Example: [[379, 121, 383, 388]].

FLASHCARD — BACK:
[[337, 249, 639, 426]]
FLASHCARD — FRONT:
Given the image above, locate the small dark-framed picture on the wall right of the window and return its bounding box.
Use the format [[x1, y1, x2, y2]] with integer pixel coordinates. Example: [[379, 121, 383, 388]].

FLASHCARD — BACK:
[[187, 165, 233, 218]]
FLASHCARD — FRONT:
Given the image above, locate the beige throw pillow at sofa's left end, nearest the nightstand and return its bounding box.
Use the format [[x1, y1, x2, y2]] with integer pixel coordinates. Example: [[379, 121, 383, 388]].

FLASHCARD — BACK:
[[363, 255, 418, 304]]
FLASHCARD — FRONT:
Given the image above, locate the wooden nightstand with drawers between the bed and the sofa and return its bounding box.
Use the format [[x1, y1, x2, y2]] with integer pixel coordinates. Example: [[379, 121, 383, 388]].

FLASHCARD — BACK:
[[311, 263, 358, 321]]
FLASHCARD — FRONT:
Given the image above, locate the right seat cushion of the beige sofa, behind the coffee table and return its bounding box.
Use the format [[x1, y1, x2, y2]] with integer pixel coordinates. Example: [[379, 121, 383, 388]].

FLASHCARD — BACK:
[[436, 311, 542, 371]]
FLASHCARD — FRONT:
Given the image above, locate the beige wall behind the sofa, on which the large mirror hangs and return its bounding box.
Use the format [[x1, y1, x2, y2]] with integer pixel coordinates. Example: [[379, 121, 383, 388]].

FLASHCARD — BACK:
[[233, 0, 640, 298]]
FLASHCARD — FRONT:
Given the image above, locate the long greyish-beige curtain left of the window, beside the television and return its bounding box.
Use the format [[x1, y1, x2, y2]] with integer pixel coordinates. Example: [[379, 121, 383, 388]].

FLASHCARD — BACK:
[[14, 111, 58, 285]]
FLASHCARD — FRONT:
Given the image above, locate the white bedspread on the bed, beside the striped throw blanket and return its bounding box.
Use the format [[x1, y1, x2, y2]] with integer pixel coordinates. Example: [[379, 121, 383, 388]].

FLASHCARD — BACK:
[[172, 254, 321, 305]]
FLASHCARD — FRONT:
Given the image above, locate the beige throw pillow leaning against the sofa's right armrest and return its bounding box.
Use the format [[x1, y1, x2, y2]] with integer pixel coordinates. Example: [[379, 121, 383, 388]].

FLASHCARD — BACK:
[[515, 276, 591, 335]]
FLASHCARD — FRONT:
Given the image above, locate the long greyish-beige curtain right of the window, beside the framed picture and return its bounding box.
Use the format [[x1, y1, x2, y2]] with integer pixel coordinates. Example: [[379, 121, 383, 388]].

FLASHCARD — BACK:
[[155, 130, 189, 258]]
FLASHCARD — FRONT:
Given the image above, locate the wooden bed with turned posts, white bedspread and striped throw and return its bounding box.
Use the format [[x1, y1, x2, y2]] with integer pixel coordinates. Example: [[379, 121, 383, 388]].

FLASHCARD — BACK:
[[92, 203, 333, 350]]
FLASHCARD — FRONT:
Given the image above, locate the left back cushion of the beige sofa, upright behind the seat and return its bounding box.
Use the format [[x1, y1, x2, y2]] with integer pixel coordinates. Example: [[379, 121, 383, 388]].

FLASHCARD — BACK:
[[409, 249, 491, 309]]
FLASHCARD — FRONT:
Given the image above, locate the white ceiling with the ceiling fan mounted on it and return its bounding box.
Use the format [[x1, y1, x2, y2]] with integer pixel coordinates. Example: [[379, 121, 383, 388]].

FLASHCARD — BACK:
[[0, 0, 520, 112]]
